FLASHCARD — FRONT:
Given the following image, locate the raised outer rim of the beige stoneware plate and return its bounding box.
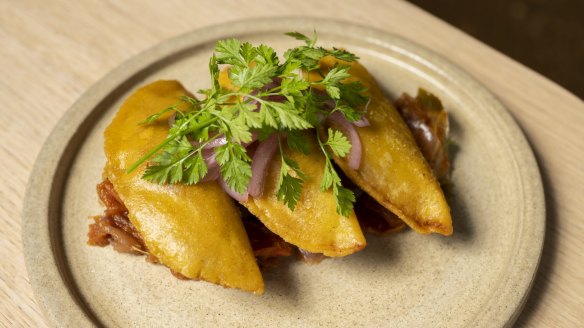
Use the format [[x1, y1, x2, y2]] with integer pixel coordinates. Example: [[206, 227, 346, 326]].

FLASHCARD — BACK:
[[22, 16, 546, 327]]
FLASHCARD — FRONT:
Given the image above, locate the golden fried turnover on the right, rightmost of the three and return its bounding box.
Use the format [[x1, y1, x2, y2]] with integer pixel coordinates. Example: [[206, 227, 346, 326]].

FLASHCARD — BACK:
[[311, 57, 452, 235]]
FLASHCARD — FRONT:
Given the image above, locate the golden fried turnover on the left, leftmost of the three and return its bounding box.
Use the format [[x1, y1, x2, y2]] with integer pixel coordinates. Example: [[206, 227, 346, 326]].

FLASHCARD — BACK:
[[95, 81, 264, 293]]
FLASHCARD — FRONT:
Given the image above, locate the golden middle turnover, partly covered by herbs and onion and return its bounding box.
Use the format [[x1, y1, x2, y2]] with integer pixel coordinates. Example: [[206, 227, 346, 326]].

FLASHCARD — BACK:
[[242, 138, 365, 257]]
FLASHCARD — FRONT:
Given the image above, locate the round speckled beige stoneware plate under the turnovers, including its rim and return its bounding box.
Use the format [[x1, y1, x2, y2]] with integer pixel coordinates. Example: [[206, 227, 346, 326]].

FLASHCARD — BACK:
[[23, 18, 545, 327]]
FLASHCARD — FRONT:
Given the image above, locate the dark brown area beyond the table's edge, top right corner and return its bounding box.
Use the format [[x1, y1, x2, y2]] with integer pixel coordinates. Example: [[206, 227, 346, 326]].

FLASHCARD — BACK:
[[409, 0, 584, 99]]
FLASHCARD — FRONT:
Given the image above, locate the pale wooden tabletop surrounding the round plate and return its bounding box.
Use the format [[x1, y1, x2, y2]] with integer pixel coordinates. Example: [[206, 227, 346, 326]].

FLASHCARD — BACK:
[[0, 0, 584, 327]]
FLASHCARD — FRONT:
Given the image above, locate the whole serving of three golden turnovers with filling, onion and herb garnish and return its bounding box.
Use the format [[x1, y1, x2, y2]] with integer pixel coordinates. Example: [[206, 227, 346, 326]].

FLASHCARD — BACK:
[[89, 32, 452, 294]]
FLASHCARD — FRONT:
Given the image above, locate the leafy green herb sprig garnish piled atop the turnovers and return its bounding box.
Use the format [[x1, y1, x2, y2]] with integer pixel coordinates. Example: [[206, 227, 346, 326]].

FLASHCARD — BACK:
[[127, 32, 368, 216]]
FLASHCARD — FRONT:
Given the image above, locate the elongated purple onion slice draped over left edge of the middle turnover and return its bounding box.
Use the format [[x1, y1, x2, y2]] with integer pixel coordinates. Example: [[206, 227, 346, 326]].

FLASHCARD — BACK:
[[247, 133, 278, 198]]
